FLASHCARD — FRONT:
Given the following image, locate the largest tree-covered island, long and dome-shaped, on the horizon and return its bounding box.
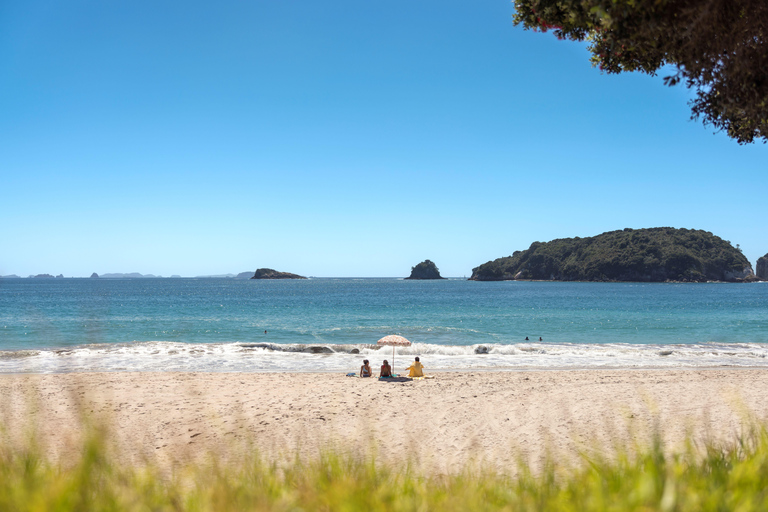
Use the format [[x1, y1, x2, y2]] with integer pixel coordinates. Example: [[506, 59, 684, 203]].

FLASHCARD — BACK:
[[470, 228, 758, 282]]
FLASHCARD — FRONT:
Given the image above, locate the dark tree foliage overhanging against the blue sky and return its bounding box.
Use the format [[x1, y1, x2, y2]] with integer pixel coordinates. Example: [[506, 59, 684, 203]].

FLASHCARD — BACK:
[[514, 0, 768, 144]]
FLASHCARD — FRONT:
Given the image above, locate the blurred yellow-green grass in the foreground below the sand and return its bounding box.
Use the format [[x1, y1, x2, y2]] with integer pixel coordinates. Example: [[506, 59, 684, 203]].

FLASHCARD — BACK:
[[0, 429, 768, 512]]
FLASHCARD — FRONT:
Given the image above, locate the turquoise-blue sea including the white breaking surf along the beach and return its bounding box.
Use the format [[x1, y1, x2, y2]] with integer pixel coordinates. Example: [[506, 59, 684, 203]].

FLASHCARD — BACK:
[[0, 279, 768, 372]]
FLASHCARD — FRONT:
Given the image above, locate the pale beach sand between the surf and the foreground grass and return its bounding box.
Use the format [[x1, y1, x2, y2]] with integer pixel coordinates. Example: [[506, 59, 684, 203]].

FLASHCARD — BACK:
[[0, 369, 768, 473]]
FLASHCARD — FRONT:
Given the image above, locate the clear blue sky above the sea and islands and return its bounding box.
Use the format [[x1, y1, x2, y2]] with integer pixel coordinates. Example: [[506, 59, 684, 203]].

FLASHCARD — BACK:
[[0, 0, 768, 276]]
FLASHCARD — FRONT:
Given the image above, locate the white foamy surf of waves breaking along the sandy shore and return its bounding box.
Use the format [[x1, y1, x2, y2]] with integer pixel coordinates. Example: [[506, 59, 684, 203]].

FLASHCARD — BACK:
[[0, 341, 768, 373]]
